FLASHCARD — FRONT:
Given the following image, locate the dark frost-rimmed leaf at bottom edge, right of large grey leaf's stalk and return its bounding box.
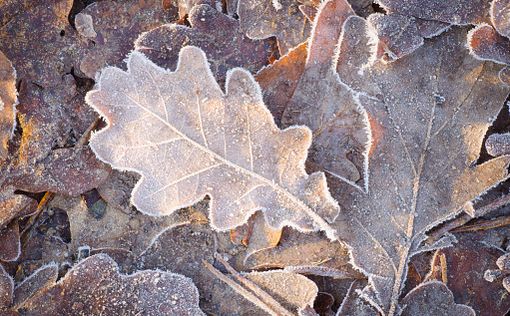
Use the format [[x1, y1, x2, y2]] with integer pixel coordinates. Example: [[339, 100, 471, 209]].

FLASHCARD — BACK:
[[401, 281, 476, 316]]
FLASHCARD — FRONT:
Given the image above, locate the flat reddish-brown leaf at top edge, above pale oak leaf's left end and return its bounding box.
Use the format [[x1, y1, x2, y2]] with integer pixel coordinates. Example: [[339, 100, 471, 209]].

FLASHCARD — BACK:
[[75, 0, 178, 79]]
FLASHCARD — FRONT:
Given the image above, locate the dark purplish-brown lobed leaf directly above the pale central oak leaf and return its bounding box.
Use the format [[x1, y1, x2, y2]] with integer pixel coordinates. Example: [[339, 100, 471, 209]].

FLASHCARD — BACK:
[[135, 4, 272, 83]]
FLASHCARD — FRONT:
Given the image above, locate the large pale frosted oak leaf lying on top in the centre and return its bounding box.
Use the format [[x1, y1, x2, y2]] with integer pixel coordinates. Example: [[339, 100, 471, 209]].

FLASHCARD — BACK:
[[87, 46, 338, 238]]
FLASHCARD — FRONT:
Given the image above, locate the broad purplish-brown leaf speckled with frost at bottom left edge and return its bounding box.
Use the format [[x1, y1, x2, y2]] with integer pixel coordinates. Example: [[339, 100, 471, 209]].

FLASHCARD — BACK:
[[19, 254, 204, 315]]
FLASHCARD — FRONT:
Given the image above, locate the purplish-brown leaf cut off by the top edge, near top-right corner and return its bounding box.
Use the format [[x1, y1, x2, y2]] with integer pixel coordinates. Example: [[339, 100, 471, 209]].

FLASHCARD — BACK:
[[377, 0, 490, 25]]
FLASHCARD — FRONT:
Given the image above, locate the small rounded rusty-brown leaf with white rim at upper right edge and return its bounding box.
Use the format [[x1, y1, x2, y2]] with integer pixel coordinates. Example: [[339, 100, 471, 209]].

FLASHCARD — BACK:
[[467, 24, 510, 65]]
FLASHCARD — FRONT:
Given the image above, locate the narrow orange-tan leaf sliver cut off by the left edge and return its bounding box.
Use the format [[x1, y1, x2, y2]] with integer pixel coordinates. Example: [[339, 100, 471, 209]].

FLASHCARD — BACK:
[[0, 52, 18, 163]]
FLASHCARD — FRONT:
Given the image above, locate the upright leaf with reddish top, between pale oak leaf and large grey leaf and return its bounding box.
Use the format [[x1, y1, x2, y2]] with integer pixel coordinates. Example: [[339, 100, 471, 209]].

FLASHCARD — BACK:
[[282, 0, 370, 188]]
